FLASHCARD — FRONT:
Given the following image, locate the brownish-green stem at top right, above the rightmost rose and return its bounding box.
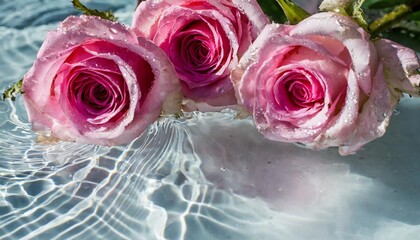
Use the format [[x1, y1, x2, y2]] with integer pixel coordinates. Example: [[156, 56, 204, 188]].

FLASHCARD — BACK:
[[369, 4, 413, 37]]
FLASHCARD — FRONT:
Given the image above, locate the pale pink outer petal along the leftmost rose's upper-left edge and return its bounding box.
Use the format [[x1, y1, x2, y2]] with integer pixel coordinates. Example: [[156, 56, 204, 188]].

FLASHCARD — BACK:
[[23, 15, 136, 126]]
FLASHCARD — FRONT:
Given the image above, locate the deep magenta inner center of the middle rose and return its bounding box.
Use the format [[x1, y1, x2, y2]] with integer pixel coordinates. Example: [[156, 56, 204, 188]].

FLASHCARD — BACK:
[[169, 19, 230, 88]]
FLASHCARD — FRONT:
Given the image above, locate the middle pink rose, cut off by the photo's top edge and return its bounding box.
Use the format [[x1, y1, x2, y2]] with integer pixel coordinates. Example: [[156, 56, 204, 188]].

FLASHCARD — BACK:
[[132, 0, 268, 106]]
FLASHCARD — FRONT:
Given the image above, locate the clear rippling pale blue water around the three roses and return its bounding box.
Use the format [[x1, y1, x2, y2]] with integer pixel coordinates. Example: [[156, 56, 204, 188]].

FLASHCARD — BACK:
[[0, 0, 420, 240]]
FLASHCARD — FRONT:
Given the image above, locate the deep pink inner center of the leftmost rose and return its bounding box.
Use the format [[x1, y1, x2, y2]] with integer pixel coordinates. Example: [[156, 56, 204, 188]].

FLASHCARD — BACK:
[[56, 40, 154, 128]]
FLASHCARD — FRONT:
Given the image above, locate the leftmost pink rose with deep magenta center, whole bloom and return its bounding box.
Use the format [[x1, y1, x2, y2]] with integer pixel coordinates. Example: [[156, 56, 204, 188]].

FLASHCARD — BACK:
[[23, 16, 180, 145]]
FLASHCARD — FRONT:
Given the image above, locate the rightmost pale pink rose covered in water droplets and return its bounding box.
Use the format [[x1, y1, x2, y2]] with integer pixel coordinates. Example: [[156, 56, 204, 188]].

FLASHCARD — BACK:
[[232, 12, 420, 155]]
